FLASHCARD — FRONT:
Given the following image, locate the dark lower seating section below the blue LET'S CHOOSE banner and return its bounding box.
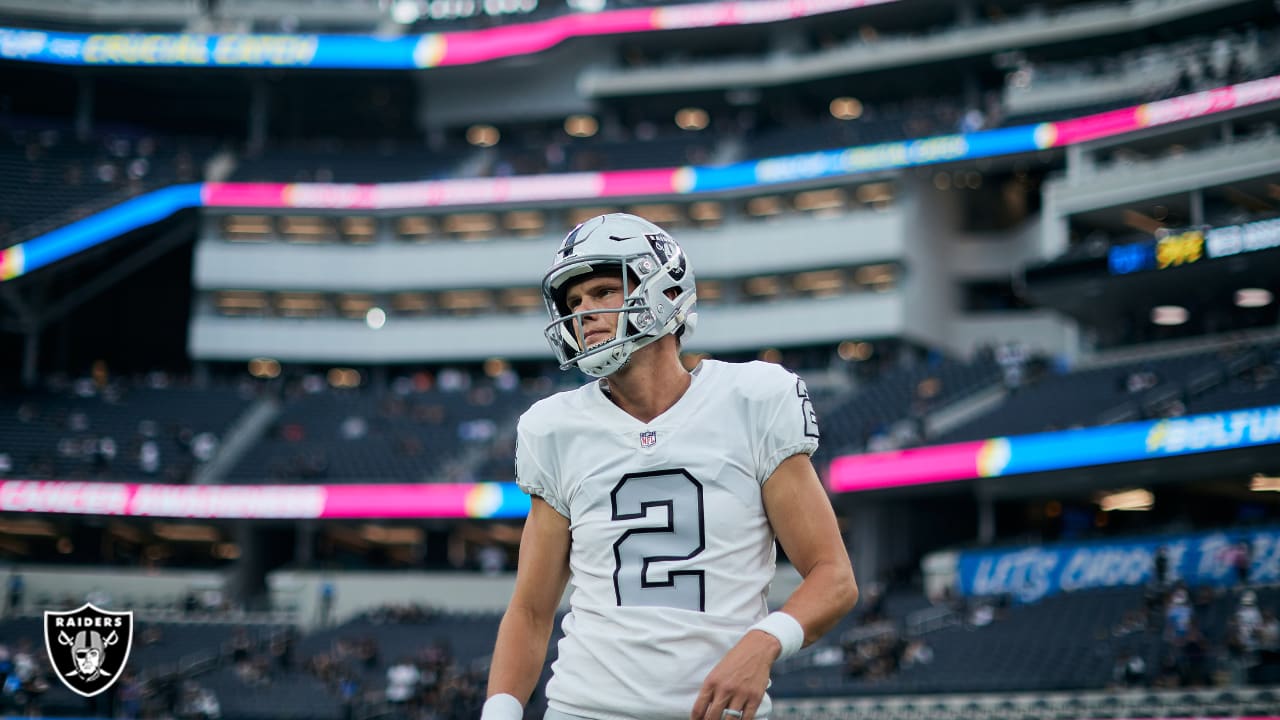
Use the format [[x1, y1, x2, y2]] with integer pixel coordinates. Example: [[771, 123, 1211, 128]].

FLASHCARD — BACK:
[[773, 579, 1280, 698]]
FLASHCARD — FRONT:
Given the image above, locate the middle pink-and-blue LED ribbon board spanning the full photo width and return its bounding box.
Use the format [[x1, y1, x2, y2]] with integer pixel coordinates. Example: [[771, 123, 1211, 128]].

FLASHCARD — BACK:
[[0, 75, 1280, 282]]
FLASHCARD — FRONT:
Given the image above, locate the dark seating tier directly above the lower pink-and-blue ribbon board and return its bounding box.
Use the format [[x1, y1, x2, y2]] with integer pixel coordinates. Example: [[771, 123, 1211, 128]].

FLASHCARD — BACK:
[[0, 333, 1280, 483]]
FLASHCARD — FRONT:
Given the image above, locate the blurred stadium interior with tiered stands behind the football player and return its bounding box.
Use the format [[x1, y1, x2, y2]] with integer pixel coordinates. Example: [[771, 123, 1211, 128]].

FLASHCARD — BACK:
[[0, 0, 1280, 720]]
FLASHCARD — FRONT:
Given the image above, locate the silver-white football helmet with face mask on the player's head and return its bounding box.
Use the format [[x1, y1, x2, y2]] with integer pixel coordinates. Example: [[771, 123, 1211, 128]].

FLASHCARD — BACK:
[[543, 213, 698, 378]]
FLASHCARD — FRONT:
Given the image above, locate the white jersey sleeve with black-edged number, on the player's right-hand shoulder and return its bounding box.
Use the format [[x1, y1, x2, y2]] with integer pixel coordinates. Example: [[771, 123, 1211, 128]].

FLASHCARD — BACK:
[[756, 366, 818, 484]]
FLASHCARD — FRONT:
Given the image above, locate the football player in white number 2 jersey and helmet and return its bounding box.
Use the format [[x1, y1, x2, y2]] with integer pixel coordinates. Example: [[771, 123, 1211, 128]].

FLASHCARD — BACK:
[[483, 214, 858, 720]]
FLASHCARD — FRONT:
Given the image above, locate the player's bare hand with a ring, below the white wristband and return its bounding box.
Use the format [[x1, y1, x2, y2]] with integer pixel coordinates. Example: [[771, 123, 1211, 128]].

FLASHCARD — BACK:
[[689, 630, 782, 720]]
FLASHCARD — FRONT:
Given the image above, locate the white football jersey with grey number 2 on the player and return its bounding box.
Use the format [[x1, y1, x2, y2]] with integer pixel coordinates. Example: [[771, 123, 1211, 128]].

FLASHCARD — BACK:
[[516, 360, 818, 720]]
